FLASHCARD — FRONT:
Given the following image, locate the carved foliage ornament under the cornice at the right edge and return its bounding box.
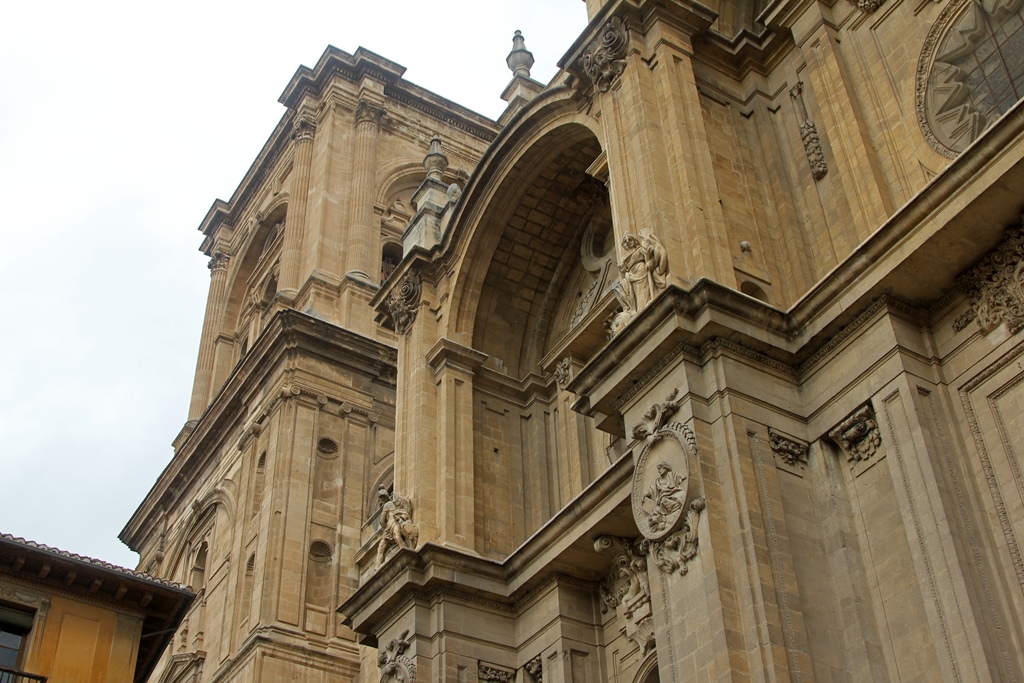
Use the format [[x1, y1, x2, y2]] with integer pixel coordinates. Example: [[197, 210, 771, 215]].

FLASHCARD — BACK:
[[953, 226, 1024, 334]]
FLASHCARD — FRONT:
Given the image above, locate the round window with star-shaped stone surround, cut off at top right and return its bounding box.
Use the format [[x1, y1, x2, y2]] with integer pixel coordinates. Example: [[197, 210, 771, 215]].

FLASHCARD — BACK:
[[916, 0, 1024, 159]]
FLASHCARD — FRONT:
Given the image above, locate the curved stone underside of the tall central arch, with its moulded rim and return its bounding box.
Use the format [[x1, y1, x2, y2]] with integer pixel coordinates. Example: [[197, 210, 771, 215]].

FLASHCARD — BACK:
[[442, 88, 601, 360]]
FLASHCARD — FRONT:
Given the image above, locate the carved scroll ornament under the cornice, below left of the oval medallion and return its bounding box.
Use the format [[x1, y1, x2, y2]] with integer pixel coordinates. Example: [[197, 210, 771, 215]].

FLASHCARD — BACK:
[[594, 536, 654, 654]]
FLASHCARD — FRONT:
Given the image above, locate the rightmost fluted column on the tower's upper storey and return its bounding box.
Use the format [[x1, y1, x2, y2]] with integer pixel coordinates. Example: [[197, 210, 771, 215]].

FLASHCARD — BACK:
[[345, 99, 384, 282]]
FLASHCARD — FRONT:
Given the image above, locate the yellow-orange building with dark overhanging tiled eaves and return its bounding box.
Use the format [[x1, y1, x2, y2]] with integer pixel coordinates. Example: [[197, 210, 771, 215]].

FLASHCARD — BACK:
[[0, 533, 196, 683]]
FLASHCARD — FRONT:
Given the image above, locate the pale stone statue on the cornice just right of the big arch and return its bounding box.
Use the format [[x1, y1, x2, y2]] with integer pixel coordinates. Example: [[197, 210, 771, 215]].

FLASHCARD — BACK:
[[611, 228, 669, 334]]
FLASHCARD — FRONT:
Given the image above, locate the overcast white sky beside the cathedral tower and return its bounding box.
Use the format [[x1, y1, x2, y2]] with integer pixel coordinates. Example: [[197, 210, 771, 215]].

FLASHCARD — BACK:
[[0, 0, 587, 566]]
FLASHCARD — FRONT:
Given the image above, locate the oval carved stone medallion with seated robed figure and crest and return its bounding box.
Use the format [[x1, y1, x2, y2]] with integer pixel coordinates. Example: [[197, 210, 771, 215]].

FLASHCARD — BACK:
[[632, 390, 696, 541]]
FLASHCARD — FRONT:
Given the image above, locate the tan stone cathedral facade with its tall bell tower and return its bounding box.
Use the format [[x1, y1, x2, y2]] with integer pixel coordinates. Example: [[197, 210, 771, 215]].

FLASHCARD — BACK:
[[123, 0, 1024, 682]]
